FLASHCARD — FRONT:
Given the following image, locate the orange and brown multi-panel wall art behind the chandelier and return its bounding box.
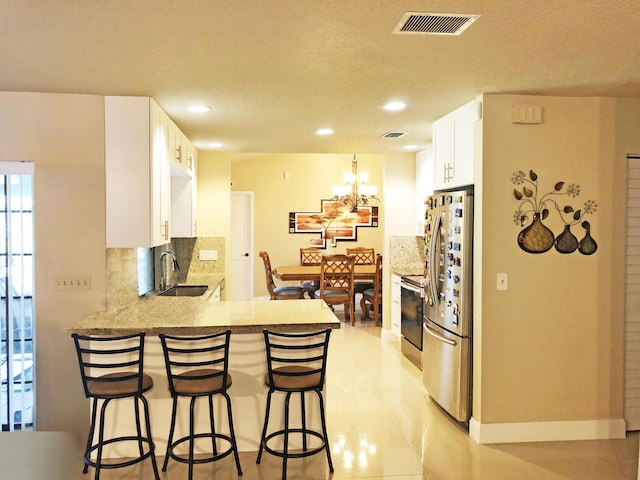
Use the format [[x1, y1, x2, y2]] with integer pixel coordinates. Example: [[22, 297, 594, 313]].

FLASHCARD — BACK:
[[289, 200, 378, 248]]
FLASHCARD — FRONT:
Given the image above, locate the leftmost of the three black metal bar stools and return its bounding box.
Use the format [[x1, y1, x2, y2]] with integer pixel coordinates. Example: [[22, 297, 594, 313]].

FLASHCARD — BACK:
[[72, 332, 160, 480]]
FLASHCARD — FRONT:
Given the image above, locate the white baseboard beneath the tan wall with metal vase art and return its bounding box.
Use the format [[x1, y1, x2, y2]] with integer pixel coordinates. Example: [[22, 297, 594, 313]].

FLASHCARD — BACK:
[[469, 418, 626, 443]]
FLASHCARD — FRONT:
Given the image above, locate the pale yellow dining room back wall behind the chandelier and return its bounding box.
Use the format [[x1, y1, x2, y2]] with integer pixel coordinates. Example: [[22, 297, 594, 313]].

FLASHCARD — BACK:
[[231, 154, 384, 297]]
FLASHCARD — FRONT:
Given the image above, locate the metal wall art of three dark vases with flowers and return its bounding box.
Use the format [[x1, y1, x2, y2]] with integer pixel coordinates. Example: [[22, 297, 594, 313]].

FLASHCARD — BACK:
[[511, 170, 598, 255]]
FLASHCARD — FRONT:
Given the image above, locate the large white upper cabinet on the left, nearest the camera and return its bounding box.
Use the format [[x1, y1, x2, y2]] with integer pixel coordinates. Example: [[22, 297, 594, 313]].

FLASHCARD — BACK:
[[105, 96, 173, 248]]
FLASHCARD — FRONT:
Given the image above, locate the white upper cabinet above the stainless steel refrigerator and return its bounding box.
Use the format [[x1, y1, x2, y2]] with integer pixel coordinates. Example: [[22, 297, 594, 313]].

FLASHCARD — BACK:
[[433, 100, 478, 190]]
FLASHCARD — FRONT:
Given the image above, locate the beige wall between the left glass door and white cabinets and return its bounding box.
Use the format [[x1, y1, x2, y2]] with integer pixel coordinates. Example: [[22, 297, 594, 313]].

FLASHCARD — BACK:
[[0, 93, 105, 438]]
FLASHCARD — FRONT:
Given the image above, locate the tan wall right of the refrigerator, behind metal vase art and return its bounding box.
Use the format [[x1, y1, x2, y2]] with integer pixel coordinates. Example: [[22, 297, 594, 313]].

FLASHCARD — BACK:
[[480, 95, 624, 424]]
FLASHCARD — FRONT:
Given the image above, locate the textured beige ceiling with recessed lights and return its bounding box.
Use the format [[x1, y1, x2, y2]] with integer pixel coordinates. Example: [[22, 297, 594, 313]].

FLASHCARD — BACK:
[[0, 0, 640, 153]]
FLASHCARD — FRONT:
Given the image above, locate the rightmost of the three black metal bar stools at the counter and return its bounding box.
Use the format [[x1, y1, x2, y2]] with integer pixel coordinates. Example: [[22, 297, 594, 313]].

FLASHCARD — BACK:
[[256, 329, 333, 480]]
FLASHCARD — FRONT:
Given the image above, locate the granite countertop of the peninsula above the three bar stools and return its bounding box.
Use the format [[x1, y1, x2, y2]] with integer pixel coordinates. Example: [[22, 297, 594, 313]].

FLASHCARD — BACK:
[[67, 295, 340, 335]]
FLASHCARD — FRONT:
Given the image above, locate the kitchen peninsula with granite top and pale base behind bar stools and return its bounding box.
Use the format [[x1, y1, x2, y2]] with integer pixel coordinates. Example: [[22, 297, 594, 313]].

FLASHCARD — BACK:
[[67, 292, 340, 457]]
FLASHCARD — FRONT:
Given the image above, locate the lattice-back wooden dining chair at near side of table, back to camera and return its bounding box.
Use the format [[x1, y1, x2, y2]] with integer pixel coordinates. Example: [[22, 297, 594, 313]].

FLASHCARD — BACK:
[[315, 254, 355, 325]]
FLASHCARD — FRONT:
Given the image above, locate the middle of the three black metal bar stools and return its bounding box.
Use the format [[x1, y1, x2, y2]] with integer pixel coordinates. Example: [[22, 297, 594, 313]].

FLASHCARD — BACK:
[[159, 330, 242, 480]]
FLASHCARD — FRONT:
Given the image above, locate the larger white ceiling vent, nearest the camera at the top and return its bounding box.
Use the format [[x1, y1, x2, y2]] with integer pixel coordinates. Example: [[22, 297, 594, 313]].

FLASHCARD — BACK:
[[393, 12, 480, 35]]
